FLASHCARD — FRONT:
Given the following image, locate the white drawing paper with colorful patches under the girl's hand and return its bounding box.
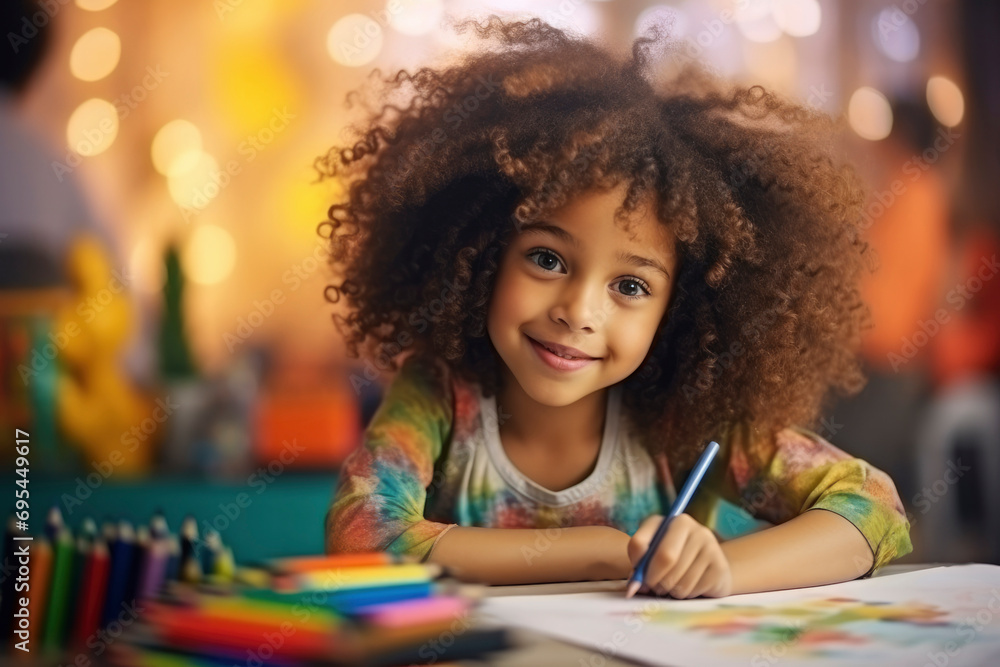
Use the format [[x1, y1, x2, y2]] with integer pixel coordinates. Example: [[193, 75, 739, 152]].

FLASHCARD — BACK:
[[479, 564, 1000, 667]]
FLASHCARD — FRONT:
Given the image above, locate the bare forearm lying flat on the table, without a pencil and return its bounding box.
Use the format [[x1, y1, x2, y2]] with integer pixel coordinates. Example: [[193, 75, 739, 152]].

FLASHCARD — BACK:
[[427, 526, 632, 585]]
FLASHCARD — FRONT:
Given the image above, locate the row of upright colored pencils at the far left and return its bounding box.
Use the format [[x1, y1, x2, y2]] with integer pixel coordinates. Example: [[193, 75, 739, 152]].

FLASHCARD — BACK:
[[0, 507, 235, 658]]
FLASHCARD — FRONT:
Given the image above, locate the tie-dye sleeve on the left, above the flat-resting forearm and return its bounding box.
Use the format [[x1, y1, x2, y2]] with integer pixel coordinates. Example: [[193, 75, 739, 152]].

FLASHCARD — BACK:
[[326, 357, 456, 561]]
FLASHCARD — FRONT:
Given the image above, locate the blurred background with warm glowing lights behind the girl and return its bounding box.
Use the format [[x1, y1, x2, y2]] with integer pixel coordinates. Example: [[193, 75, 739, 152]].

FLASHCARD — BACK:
[[0, 0, 1000, 563]]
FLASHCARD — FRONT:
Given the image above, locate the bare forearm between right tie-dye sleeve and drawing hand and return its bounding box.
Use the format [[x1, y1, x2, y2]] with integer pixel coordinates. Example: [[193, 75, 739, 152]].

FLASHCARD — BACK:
[[720, 509, 874, 595]]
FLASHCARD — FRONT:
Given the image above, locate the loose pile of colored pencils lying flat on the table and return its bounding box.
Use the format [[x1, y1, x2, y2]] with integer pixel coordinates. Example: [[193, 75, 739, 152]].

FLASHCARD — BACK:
[[111, 553, 509, 667]]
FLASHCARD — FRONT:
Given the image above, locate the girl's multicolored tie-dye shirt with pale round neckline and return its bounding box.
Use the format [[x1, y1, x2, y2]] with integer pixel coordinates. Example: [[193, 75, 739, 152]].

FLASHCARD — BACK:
[[326, 357, 912, 576]]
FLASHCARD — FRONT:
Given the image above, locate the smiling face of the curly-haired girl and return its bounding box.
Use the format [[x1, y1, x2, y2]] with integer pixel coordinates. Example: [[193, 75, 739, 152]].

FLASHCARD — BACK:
[[487, 186, 677, 407]]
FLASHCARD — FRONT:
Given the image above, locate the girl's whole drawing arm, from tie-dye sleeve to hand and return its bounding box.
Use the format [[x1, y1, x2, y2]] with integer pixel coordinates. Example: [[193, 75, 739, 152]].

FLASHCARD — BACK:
[[628, 428, 912, 598]]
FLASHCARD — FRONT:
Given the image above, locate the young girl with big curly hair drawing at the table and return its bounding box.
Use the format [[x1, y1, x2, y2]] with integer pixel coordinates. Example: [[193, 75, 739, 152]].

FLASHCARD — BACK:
[[318, 17, 911, 598]]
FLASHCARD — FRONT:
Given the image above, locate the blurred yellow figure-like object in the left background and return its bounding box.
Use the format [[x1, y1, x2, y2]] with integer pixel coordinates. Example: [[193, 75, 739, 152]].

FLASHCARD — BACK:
[[55, 236, 159, 475]]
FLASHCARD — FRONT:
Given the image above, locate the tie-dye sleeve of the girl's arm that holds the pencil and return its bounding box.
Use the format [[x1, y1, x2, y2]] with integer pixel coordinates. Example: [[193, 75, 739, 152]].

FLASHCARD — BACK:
[[708, 425, 913, 577]]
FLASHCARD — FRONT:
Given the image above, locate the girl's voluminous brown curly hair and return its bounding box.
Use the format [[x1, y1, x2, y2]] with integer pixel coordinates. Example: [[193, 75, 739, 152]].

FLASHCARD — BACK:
[[315, 16, 872, 469]]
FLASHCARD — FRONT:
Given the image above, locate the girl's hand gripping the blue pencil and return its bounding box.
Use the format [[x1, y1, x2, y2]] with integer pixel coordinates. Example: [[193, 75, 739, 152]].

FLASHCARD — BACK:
[[628, 514, 733, 598]]
